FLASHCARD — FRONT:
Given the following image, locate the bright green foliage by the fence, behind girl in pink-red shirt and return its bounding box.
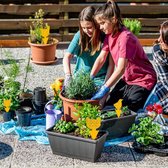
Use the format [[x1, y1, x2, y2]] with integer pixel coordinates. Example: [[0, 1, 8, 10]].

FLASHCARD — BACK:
[[123, 18, 142, 36]]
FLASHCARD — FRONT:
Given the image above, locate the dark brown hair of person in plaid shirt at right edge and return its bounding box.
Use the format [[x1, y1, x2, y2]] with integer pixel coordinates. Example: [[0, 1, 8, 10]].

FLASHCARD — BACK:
[[160, 20, 168, 45]]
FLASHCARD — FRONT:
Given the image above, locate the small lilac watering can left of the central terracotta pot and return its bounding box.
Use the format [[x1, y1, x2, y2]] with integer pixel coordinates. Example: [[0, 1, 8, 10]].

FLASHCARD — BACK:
[[44, 100, 62, 129]]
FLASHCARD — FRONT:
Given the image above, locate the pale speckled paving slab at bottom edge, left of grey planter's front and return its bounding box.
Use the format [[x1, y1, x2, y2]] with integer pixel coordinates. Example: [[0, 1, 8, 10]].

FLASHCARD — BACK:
[[11, 141, 73, 168]]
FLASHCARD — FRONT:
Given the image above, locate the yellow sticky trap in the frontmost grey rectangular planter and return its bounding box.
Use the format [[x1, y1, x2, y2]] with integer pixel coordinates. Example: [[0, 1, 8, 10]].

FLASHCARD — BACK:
[[86, 117, 101, 139]]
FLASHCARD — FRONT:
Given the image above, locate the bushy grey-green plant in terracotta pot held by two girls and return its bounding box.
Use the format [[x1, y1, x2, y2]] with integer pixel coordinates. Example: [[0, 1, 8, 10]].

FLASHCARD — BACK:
[[59, 71, 99, 121]]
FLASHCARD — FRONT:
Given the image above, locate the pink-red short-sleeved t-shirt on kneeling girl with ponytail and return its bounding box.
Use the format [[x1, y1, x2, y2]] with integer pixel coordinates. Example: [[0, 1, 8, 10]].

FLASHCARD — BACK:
[[102, 28, 156, 90]]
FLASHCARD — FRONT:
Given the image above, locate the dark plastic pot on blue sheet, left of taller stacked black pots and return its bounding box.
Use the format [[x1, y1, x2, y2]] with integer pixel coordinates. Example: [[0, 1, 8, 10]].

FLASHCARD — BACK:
[[16, 106, 32, 127]]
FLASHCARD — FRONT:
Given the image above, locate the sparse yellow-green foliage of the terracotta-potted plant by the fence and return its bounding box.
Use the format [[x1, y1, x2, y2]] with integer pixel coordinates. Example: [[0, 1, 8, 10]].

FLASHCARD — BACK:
[[29, 9, 48, 44]]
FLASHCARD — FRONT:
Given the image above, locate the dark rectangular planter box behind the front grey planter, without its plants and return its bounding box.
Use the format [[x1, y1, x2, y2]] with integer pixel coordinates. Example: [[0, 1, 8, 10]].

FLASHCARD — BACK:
[[100, 111, 137, 140]]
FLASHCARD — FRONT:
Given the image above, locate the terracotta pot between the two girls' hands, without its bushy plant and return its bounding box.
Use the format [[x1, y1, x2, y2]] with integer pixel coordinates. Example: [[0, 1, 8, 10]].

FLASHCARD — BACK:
[[59, 93, 99, 122]]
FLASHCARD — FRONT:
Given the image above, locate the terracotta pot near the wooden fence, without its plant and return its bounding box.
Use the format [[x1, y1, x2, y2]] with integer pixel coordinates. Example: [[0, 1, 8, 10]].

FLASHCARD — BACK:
[[28, 39, 58, 65]]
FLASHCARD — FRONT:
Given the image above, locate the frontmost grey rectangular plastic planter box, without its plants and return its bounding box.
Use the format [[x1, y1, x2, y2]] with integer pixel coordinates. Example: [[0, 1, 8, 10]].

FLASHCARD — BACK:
[[46, 128, 108, 162]]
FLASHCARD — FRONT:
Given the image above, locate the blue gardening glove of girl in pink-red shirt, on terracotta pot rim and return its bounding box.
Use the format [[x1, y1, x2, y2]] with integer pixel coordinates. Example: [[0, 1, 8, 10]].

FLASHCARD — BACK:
[[91, 85, 110, 100]]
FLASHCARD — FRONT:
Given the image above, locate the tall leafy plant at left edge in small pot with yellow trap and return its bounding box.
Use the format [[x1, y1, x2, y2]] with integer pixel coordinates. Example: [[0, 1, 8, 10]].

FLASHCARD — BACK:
[[0, 50, 21, 121]]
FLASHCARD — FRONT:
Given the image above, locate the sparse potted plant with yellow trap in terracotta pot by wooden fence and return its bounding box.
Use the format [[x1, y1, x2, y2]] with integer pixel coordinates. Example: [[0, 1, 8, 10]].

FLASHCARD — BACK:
[[28, 9, 58, 64]]
